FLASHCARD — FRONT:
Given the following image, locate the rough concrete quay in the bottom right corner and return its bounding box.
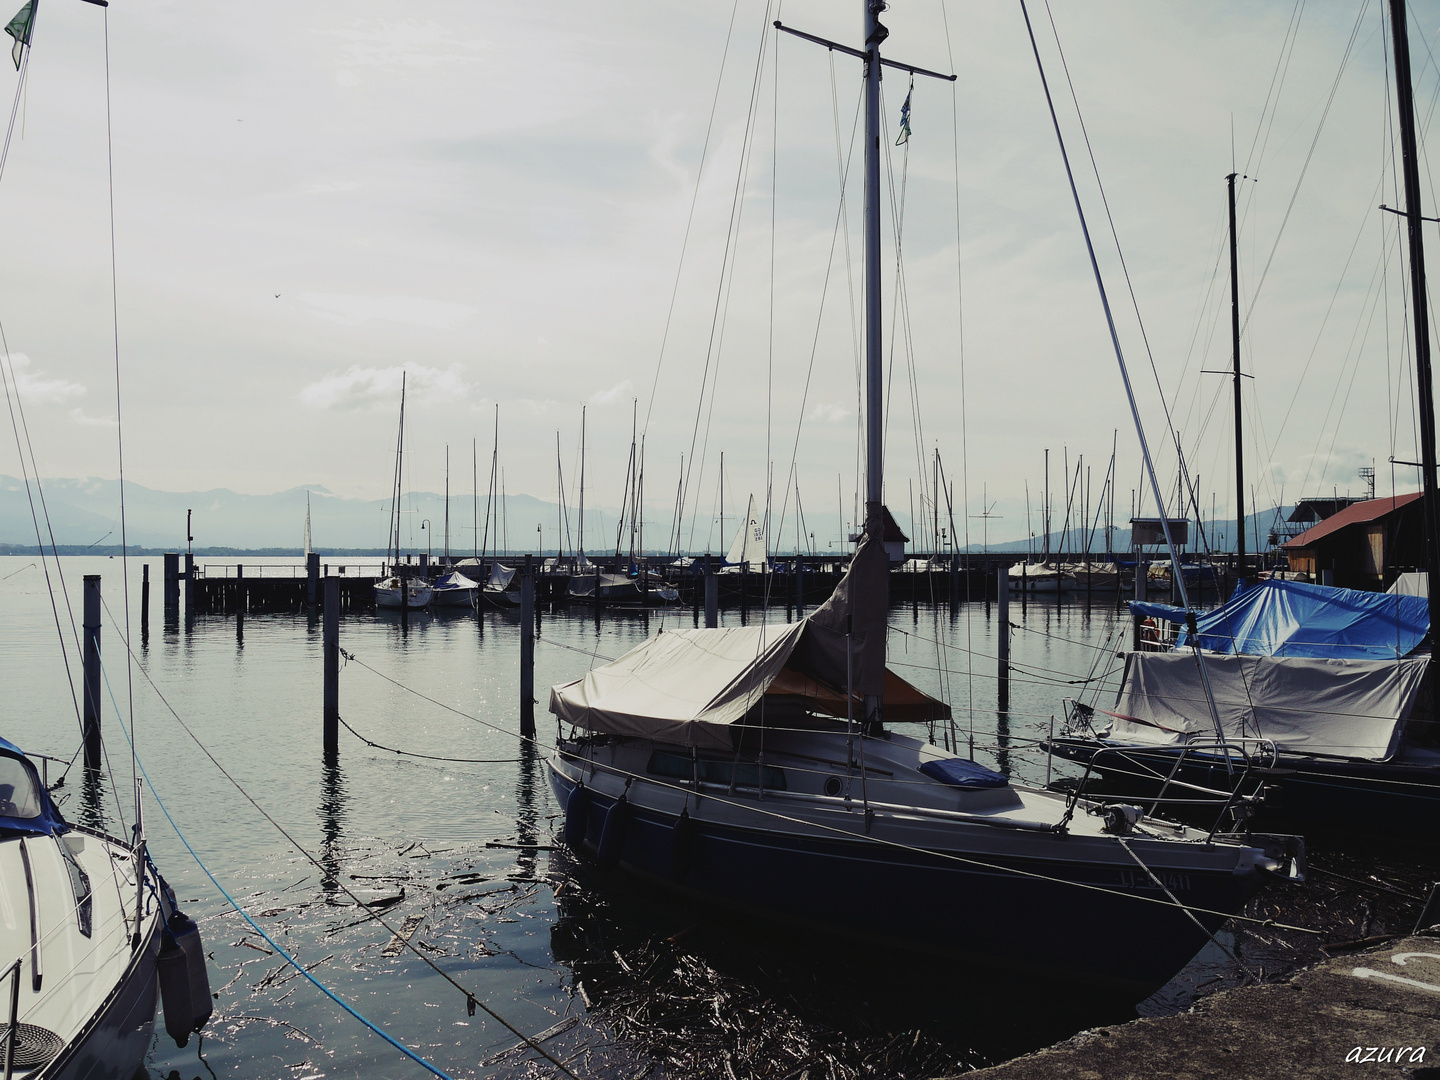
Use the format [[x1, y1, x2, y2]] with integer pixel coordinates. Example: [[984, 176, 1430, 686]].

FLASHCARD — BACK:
[[965, 936, 1440, 1080]]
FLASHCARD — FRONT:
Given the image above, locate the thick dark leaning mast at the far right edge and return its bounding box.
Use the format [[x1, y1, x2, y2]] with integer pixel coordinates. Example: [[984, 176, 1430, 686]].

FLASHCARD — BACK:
[[1390, 0, 1440, 661]]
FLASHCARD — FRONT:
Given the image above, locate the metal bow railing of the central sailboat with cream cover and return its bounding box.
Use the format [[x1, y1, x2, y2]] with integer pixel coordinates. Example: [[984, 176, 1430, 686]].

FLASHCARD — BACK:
[[1051, 722, 1277, 840]]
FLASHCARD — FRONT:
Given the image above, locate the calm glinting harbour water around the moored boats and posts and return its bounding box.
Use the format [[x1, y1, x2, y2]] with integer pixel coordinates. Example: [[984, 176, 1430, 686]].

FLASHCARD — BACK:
[[0, 557, 1324, 1080]]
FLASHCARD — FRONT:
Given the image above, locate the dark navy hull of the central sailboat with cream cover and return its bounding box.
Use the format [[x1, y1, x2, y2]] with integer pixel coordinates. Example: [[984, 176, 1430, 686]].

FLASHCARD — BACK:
[[550, 759, 1278, 1001]]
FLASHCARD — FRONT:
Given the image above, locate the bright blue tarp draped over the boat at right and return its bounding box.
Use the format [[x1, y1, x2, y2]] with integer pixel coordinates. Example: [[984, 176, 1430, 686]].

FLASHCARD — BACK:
[[1130, 579, 1430, 660]]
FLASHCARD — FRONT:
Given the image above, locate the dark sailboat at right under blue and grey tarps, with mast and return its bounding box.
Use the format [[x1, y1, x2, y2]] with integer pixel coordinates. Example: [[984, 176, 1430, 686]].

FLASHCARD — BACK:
[[1051, 0, 1440, 841]]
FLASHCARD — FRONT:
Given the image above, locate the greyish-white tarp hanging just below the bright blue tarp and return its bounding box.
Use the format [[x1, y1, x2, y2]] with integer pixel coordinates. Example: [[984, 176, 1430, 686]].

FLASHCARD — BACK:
[[1102, 649, 1428, 762]]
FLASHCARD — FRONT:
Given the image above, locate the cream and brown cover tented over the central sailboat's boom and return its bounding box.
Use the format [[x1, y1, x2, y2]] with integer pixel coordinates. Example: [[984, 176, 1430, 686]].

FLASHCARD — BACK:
[[550, 527, 950, 749]]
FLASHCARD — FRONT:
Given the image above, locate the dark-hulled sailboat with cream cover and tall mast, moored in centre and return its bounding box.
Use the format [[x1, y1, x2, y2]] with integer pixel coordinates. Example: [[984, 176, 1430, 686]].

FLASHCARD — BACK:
[[547, 0, 1303, 999]]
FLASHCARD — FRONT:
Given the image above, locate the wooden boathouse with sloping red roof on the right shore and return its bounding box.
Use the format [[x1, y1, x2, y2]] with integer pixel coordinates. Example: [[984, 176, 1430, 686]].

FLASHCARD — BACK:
[[1282, 491, 1424, 590]]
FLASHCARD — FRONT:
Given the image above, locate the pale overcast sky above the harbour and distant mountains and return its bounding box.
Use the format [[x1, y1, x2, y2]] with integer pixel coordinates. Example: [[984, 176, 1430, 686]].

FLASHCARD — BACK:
[[0, 0, 1440, 547]]
